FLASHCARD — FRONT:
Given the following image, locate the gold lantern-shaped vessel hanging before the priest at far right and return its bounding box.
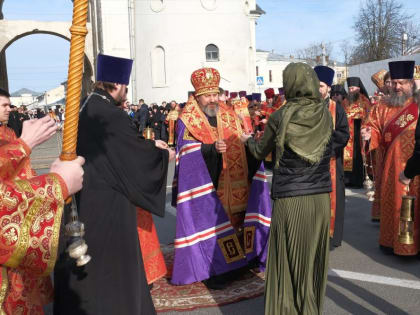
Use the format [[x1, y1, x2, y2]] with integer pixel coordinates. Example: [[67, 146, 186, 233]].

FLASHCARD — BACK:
[[398, 185, 416, 245]]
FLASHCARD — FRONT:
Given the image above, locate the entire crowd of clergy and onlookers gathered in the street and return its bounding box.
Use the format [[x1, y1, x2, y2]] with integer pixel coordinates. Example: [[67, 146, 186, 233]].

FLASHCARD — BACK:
[[0, 50, 420, 315]]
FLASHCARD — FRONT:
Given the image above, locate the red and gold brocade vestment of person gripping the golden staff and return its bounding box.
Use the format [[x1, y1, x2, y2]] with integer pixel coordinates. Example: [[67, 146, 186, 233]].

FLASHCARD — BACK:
[[0, 128, 68, 314]]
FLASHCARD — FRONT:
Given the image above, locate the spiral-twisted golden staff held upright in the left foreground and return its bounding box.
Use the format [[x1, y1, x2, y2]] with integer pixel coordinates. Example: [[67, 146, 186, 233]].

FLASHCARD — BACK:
[[60, 0, 88, 165]]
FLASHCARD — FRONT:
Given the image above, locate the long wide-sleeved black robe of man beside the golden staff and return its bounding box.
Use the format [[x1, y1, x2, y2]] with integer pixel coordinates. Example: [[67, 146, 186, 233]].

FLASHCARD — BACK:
[[54, 90, 168, 315]]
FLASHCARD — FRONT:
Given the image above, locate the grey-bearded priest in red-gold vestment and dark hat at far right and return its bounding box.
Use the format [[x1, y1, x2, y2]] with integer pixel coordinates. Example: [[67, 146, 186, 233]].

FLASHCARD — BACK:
[[361, 61, 420, 255]]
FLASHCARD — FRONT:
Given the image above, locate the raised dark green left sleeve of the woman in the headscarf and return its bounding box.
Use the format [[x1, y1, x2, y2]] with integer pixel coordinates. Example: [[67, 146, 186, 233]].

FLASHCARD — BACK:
[[246, 115, 277, 160]]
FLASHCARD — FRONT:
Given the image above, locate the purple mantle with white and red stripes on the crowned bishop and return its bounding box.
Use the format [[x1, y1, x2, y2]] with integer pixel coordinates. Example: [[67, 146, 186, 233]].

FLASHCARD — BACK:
[[171, 119, 271, 285]]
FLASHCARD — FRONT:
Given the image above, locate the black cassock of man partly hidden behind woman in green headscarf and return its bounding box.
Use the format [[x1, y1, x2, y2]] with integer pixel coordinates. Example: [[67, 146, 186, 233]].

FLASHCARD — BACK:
[[331, 103, 350, 246]]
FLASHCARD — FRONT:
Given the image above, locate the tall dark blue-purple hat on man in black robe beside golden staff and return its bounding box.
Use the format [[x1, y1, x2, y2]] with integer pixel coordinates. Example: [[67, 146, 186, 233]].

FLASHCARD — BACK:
[[96, 54, 133, 85]]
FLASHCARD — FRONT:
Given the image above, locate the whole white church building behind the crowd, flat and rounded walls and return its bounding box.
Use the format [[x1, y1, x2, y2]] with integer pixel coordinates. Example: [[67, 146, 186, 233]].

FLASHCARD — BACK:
[[94, 0, 264, 104]]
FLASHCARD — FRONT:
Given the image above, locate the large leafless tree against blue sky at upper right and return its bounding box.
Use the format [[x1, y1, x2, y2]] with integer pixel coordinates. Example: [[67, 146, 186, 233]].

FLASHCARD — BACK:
[[350, 0, 418, 64]]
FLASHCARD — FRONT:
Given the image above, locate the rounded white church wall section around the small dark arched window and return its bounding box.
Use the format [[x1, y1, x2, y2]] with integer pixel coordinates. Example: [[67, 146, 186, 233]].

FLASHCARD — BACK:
[[135, 0, 255, 103]]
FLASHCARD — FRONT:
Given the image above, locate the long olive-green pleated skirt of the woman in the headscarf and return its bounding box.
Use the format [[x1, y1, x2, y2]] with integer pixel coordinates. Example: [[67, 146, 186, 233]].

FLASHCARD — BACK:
[[265, 194, 331, 315]]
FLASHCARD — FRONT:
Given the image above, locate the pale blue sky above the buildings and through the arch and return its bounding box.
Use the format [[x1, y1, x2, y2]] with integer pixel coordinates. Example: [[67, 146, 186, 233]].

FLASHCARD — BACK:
[[3, 0, 420, 92]]
